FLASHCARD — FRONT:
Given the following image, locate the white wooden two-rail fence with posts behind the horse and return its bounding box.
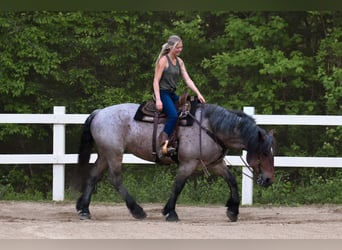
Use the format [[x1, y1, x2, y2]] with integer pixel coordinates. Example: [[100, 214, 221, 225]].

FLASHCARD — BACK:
[[0, 106, 342, 205]]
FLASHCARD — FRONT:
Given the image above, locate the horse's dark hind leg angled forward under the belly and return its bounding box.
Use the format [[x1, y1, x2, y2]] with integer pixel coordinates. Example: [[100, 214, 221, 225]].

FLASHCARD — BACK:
[[109, 158, 146, 219]]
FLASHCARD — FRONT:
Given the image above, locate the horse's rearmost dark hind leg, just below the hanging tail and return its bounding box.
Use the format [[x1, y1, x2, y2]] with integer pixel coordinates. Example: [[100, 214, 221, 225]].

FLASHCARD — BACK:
[[76, 159, 107, 220]]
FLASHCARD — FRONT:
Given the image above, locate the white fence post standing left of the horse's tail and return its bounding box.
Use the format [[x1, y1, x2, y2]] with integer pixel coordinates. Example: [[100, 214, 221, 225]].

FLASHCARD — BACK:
[[52, 106, 65, 201]]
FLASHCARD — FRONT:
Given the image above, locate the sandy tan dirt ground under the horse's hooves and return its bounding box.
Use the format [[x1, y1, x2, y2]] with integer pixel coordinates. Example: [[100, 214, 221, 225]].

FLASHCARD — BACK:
[[0, 201, 342, 239]]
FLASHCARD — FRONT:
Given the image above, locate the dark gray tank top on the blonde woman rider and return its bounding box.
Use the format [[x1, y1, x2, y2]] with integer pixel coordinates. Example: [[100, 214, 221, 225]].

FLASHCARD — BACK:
[[159, 55, 180, 92]]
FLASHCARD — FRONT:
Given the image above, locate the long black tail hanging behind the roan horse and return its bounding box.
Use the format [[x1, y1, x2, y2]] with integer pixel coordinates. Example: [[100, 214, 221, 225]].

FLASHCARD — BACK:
[[72, 110, 99, 192]]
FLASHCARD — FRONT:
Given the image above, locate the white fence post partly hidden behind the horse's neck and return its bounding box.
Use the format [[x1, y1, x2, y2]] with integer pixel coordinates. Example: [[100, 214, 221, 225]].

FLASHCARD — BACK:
[[241, 107, 255, 205]]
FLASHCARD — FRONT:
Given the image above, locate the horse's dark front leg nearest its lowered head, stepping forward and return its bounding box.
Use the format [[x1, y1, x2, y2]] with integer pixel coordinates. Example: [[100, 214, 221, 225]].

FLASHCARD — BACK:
[[214, 162, 240, 222]]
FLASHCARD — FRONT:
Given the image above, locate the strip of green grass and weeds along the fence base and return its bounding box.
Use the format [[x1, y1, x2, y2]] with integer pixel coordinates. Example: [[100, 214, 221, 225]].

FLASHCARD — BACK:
[[0, 166, 342, 206]]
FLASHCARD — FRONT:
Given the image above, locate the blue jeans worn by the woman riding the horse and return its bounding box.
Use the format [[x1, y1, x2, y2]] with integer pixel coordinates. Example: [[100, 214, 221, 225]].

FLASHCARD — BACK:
[[160, 90, 179, 136]]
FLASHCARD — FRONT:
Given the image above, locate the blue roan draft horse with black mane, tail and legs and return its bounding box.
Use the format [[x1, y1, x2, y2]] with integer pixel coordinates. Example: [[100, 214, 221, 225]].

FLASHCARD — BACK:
[[76, 103, 275, 222]]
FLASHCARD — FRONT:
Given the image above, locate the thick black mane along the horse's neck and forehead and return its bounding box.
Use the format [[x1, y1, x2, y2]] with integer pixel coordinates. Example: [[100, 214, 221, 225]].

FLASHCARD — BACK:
[[204, 104, 272, 153]]
